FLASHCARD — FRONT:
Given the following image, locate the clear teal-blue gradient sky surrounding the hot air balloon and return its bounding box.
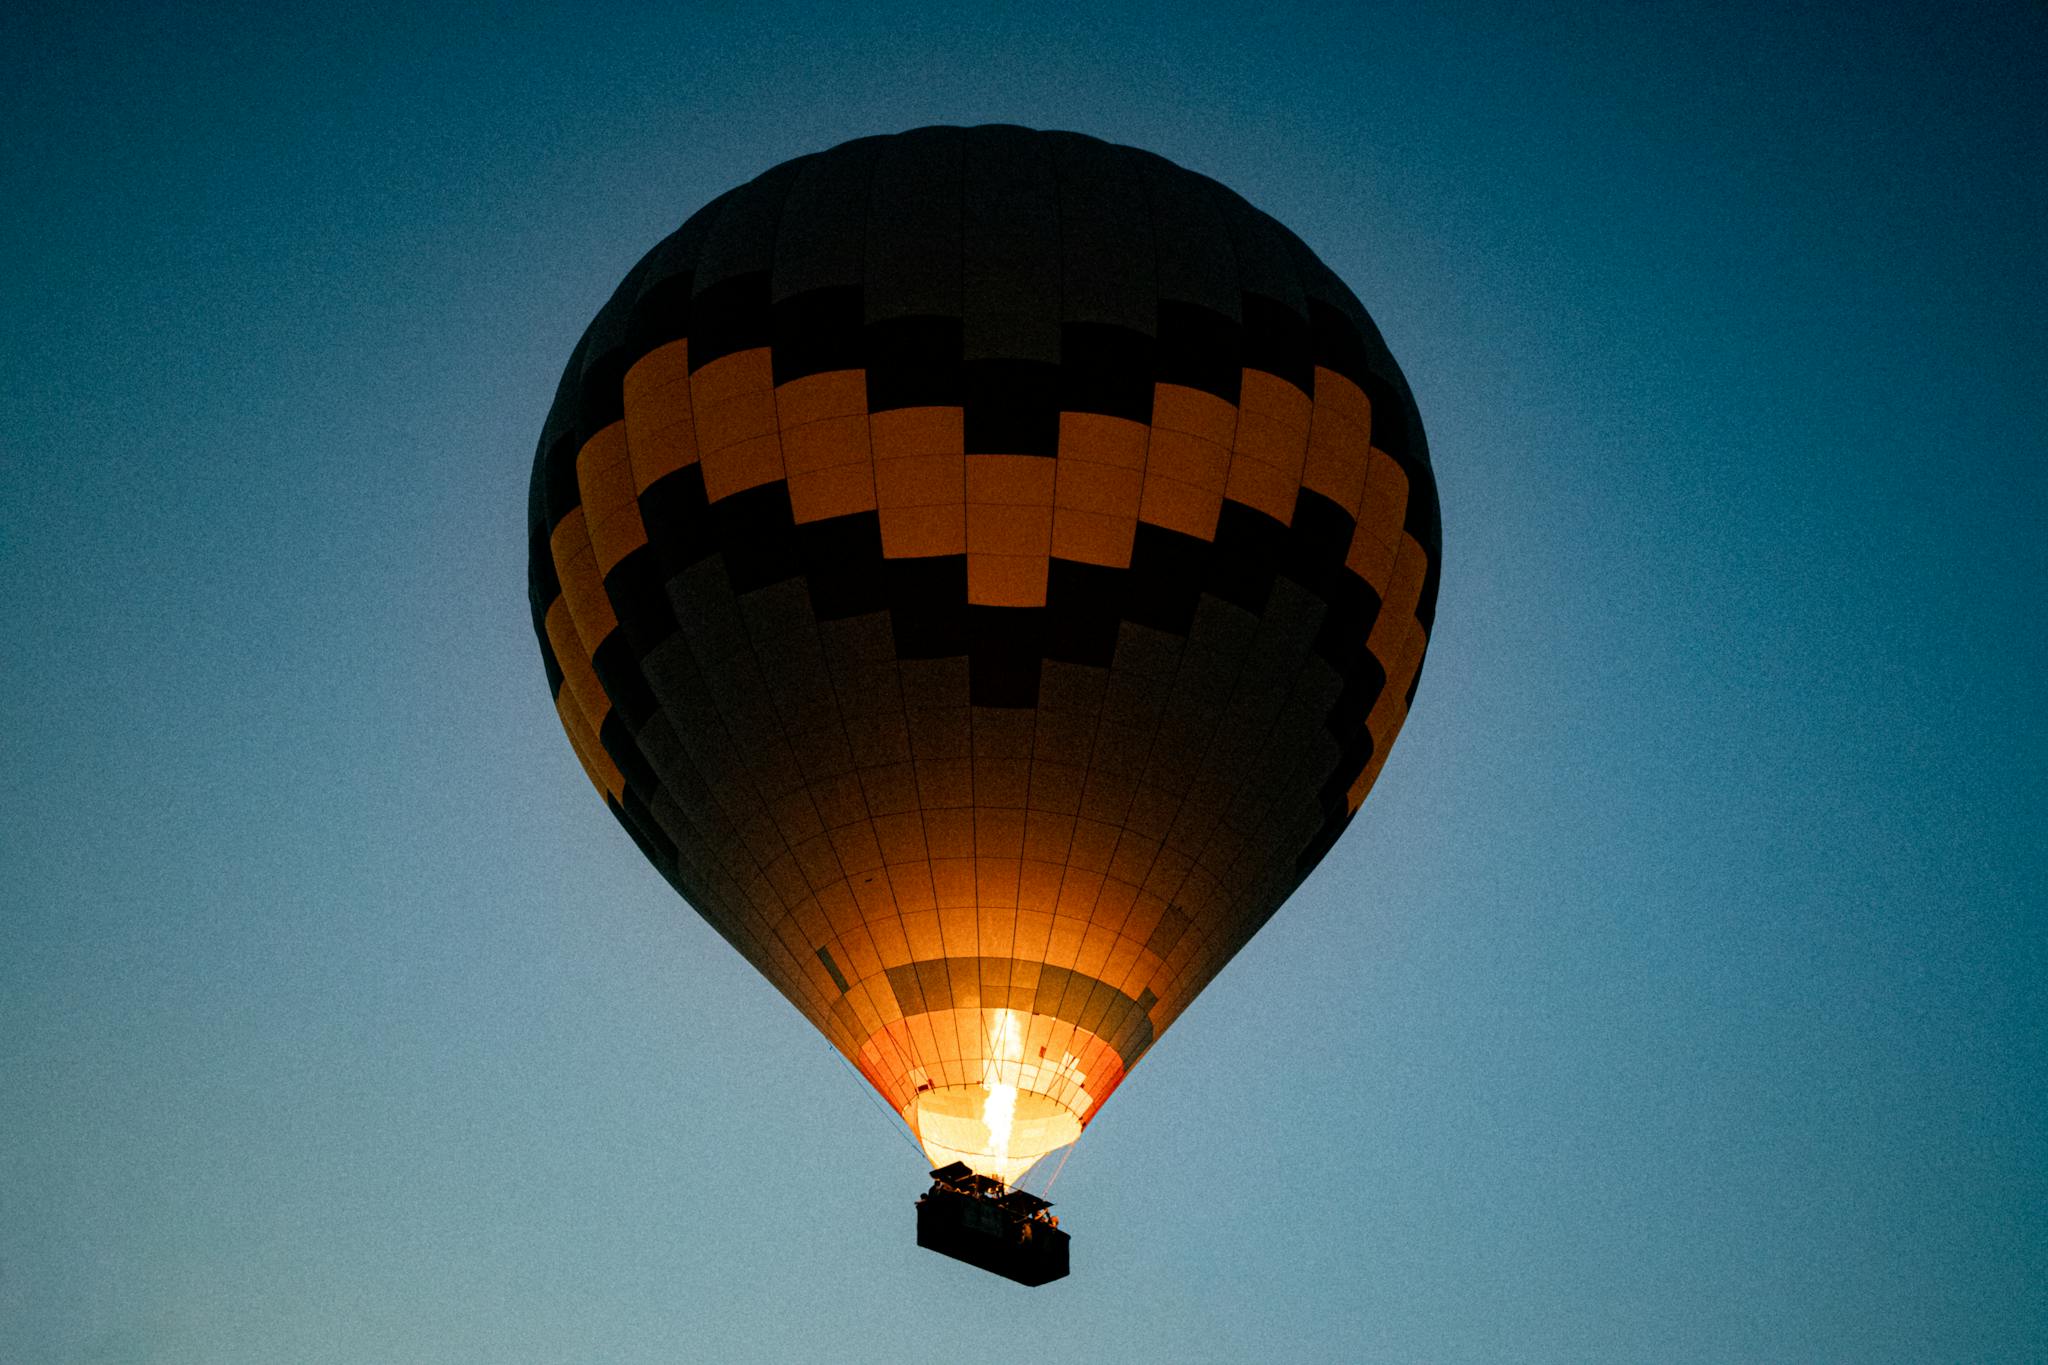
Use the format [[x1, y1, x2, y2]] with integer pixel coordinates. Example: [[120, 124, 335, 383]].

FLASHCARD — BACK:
[[0, 0, 2048, 1365]]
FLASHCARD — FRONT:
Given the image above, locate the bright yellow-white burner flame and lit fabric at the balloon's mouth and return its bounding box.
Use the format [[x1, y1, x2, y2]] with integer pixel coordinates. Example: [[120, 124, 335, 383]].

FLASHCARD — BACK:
[[903, 1009, 1087, 1185]]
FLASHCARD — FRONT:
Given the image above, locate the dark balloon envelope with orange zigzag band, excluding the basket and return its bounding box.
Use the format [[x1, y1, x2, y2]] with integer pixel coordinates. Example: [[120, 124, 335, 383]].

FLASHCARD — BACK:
[[530, 127, 1442, 1265]]
